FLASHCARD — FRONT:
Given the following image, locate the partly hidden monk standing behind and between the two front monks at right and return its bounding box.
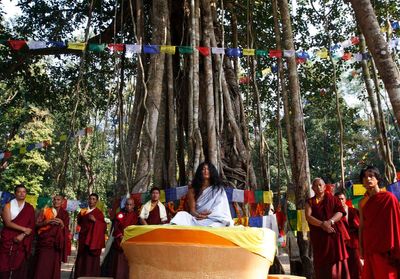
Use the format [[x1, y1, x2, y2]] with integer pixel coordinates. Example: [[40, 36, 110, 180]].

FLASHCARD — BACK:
[[335, 192, 362, 279]]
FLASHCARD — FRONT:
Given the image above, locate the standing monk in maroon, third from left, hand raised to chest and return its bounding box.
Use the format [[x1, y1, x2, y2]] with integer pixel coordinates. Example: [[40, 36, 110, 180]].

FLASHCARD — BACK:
[[75, 193, 106, 278]]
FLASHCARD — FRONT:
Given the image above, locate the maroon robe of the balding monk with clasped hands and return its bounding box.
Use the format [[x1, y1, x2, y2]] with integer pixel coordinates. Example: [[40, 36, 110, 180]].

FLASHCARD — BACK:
[[307, 193, 350, 278]]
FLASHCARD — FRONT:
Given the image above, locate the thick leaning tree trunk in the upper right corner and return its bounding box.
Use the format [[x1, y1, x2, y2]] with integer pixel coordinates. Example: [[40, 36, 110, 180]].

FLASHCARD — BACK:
[[350, 0, 400, 125]]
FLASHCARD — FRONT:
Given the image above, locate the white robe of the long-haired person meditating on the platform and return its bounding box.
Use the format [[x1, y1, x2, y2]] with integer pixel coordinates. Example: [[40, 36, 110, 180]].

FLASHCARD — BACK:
[[170, 186, 233, 227]]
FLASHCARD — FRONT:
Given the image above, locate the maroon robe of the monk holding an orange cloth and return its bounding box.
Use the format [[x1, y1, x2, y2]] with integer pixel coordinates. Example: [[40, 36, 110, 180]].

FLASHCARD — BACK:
[[34, 208, 69, 279]]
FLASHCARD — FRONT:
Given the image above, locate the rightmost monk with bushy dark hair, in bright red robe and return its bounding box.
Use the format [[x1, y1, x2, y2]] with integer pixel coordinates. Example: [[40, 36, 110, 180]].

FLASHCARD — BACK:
[[360, 166, 400, 279]]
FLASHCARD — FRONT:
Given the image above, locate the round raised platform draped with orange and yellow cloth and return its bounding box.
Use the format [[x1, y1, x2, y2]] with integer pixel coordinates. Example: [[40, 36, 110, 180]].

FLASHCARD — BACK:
[[122, 226, 276, 279]]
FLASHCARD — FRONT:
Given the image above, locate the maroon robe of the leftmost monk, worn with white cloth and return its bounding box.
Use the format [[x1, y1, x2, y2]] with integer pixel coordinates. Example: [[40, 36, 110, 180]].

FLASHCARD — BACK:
[[0, 202, 35, 279]]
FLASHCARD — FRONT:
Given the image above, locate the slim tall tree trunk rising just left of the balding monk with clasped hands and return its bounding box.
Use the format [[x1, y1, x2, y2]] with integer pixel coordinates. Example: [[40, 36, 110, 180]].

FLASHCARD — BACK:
[[278, 0, 313, 278]]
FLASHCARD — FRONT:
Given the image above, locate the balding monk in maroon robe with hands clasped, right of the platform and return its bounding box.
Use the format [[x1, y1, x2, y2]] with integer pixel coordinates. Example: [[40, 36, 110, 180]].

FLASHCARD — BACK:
[[305, 178, 350, 279]]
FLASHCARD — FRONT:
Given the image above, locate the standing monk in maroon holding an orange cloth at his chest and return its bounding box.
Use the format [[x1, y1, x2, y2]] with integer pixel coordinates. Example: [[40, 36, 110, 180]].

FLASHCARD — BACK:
[[34, 195, 69, 279]]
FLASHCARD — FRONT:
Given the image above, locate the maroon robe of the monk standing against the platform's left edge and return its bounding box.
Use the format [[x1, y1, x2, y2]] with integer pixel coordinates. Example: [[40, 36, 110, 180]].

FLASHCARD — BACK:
[[110, 212, 139, 279]]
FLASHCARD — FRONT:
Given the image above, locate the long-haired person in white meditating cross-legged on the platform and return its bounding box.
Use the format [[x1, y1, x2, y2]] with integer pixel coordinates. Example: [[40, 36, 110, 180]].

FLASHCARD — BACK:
[[170, 162, 233, 227]]
